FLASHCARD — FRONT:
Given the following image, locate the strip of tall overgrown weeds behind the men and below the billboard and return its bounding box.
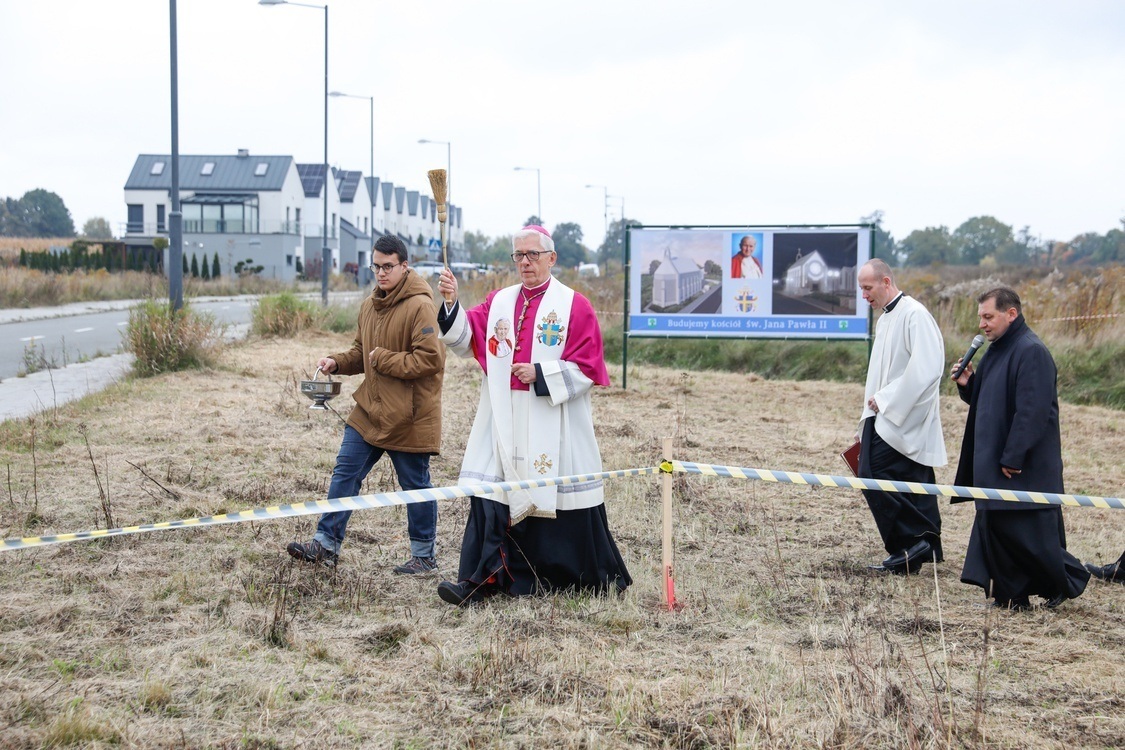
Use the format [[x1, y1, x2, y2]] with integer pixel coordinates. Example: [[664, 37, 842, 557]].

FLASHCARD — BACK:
[[589, 260, 1125, 409]]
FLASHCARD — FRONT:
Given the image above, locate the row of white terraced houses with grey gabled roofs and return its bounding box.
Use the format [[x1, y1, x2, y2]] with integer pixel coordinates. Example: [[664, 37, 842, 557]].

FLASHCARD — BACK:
[[119, 148, 468, 282]]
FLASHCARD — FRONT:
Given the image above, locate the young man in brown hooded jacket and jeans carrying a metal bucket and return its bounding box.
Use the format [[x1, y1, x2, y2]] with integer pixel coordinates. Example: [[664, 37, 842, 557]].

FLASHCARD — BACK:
[[287, 235, 446, 573]]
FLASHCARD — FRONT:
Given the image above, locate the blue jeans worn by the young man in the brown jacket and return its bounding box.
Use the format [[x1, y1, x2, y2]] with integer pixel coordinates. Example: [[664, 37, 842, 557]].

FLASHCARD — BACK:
[[313, 425, 438, 558]]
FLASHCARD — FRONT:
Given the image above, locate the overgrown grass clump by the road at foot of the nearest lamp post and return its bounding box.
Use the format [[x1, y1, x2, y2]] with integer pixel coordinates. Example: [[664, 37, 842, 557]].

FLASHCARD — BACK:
[[126, 299, 223, 378]]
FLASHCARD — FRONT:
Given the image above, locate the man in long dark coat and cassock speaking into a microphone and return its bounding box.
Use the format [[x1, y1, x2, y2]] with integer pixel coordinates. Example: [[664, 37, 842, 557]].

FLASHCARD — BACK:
[[951, 287, 1090, 609]]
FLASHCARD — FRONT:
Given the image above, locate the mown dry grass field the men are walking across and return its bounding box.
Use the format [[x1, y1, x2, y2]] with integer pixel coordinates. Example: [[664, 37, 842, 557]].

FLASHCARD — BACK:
[[0, 334, 1125, 749]]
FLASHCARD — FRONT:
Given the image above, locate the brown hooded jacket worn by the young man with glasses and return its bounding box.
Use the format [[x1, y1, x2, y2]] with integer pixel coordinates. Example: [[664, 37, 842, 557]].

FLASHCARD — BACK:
[[330, 268, 446, 454]]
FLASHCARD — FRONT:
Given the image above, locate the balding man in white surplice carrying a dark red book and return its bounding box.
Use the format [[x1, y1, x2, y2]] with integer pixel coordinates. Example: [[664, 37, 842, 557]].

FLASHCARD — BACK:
[[857, 259, 946, 573]]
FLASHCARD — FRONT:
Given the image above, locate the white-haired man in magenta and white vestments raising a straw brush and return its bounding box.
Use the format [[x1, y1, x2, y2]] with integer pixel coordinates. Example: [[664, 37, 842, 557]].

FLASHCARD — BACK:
[[438, 225, 632, 605]]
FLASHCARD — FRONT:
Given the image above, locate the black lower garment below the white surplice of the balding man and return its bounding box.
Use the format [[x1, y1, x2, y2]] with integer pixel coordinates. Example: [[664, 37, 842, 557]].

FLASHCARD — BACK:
[[860, 417, 944, 561]]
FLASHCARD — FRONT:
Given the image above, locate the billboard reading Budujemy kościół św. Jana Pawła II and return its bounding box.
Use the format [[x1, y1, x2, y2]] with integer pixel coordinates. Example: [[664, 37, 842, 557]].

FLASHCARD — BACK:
[[627, 225, 871, 338]]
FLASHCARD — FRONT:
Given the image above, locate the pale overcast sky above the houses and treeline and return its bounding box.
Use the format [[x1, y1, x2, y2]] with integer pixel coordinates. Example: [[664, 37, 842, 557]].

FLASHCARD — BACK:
[[0, 0, 1125, 247]]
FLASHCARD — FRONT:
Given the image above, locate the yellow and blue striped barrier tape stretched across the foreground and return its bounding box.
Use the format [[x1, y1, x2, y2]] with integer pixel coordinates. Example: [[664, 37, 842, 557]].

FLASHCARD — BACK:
[[0, 461, 1125, 552]]
